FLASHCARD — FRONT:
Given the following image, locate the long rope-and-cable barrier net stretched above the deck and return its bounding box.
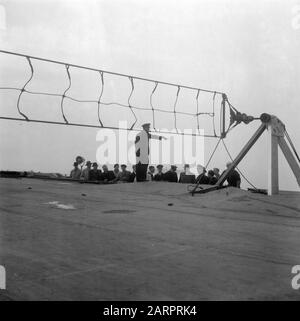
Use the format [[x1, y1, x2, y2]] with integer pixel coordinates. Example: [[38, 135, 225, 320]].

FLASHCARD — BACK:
[[0, 51, 229, 137]]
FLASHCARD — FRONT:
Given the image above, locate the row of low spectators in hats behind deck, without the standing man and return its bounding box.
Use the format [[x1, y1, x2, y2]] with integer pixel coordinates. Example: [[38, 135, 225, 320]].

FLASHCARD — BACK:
[[70, 161, 241, 187]]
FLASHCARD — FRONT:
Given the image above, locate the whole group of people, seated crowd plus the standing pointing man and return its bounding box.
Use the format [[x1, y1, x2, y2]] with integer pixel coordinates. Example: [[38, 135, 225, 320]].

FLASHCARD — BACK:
[[70, 123, 241, 187]]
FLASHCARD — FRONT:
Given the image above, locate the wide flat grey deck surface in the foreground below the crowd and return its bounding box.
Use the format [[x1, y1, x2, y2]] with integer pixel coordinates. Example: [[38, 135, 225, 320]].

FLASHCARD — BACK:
[[0, 178, 300, 300]]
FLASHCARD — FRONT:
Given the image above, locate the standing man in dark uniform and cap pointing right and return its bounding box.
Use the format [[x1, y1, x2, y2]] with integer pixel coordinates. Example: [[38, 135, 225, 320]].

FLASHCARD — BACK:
[[135, 123, 166, 182]]
